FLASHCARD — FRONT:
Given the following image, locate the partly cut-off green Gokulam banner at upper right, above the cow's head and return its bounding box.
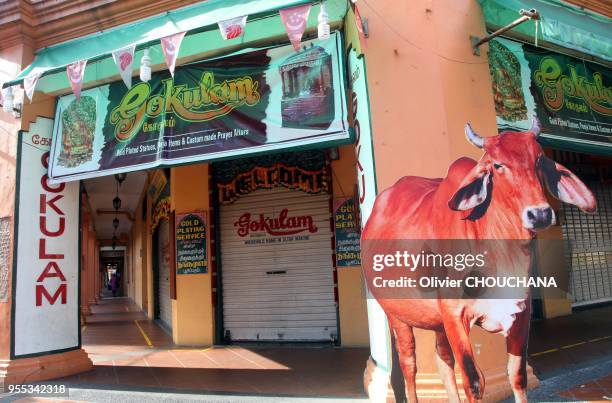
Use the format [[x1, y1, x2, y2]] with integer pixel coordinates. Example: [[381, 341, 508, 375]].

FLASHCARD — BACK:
[[489, 39, 612, 152]]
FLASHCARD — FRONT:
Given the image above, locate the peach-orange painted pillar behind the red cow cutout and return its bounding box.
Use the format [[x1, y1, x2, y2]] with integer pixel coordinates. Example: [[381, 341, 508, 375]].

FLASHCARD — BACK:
[[359, 0, 532, 400]]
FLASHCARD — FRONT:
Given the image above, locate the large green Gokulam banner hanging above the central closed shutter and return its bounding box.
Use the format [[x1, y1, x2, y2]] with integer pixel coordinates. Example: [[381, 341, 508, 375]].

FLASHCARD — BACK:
[[49, 34, 350, 183]]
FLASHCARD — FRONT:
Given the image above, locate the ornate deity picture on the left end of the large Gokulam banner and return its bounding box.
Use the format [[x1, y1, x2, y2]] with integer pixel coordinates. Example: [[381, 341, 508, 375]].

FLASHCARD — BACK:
[[57, 96, 96, 168]]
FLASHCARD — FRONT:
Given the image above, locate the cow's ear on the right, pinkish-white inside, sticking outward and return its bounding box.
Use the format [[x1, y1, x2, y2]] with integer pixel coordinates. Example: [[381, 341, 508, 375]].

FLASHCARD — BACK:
[[537, 155, 597, 213]]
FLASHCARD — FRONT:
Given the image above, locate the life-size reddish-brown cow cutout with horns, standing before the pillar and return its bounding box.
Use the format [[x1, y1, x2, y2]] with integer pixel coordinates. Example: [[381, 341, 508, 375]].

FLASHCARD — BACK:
[[362, 119, 596, 402]]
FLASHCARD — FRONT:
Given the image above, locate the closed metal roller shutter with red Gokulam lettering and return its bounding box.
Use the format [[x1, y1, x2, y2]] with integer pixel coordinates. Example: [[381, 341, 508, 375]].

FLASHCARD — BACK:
[[220, 187, 337, 341]]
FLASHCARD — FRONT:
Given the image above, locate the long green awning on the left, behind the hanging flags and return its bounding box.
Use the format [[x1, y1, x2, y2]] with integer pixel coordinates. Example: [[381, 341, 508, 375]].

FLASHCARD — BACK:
[[4, 0, 348, 94]]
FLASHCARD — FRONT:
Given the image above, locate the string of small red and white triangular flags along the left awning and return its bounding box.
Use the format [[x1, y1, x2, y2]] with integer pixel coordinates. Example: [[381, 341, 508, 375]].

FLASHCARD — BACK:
[[5, 0, 363, 102]]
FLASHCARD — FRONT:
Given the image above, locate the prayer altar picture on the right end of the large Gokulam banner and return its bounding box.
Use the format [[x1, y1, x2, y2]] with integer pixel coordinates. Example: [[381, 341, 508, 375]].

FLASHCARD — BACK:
[[279, 44, 335, 130]]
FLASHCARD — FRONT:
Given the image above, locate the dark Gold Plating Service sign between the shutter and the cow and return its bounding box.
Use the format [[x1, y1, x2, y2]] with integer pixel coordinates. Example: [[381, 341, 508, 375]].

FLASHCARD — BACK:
[[334, 197, 361, 267]]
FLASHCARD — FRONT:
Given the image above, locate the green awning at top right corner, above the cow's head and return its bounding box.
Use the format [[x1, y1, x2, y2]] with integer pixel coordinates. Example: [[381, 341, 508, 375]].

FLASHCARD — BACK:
[[478, 0, 612, 61]]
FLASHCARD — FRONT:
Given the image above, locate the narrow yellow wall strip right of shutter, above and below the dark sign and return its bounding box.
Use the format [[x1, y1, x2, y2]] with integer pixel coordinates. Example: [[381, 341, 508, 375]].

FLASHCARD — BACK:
[[331, 145, 369, 347]]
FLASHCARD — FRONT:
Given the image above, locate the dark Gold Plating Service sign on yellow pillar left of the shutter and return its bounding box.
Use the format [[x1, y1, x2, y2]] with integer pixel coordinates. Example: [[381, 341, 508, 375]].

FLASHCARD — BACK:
[[174, 212, 208, 274]]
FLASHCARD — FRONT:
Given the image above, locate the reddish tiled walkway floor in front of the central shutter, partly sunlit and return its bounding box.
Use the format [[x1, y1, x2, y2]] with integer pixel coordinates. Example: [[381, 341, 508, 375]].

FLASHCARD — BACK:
[[60, 298, 369, 397]]
